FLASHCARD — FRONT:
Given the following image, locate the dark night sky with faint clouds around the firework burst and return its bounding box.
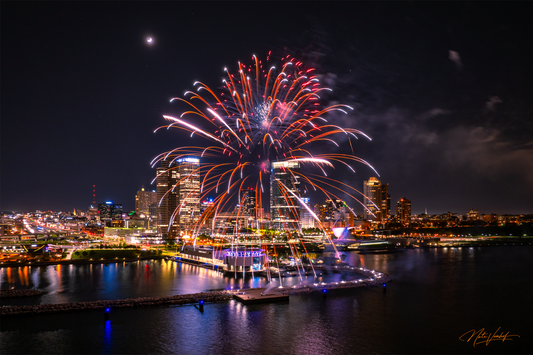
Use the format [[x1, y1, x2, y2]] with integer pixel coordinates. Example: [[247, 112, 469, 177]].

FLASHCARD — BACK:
[[0, 1, 533, 214]]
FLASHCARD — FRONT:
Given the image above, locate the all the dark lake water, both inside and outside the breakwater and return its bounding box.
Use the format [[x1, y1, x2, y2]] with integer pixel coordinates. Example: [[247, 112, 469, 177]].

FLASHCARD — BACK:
[[0, 247, 533, 355]]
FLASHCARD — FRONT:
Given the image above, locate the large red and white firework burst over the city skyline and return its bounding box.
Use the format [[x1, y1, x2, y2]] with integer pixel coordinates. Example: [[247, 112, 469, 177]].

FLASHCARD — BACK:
[[152, 53, 377, 262]]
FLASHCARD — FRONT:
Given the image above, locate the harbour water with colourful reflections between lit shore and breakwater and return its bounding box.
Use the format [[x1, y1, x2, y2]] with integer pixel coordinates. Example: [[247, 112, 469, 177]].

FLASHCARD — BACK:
[[0, 260, 360, 305]]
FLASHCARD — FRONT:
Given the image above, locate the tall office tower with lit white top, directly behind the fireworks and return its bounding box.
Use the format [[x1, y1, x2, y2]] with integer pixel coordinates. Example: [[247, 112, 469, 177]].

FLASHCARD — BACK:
[[270, 161, 300, 229]]
